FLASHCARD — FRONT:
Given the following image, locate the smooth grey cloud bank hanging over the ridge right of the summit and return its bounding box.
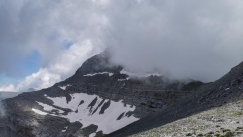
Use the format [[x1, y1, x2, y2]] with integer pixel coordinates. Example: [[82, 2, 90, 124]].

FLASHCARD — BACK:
[[109, 0, 243, 81]]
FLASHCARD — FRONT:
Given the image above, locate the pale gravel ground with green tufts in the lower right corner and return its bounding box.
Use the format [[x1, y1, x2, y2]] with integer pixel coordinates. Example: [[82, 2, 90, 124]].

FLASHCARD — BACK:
[[130, 97, 243, 137]]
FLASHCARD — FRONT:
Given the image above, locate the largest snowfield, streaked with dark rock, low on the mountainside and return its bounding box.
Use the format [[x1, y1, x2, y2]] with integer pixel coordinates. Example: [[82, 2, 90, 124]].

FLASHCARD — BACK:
[[32, 93, 139, 135]]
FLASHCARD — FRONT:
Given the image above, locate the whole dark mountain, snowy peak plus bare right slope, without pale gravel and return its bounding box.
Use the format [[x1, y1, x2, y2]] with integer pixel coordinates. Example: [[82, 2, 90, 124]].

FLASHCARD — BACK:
[[0, 52, 243, 137]]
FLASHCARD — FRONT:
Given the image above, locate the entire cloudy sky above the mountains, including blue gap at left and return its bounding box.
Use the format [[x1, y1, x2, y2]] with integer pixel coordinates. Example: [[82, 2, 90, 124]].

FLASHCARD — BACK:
[[0, 0, 243, 91]]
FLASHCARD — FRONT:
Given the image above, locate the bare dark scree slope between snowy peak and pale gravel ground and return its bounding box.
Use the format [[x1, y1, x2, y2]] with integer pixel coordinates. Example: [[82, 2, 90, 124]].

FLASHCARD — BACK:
[[109, 62, 243, 137]]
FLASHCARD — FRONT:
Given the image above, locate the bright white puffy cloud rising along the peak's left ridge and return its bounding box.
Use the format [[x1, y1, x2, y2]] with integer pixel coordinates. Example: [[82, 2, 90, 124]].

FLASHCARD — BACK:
[[12, 40, 93, 91]]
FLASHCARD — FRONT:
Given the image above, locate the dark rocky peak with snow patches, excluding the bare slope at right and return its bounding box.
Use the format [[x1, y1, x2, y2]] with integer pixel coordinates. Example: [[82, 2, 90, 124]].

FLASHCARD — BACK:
[[0, 52, 199, 137]]
